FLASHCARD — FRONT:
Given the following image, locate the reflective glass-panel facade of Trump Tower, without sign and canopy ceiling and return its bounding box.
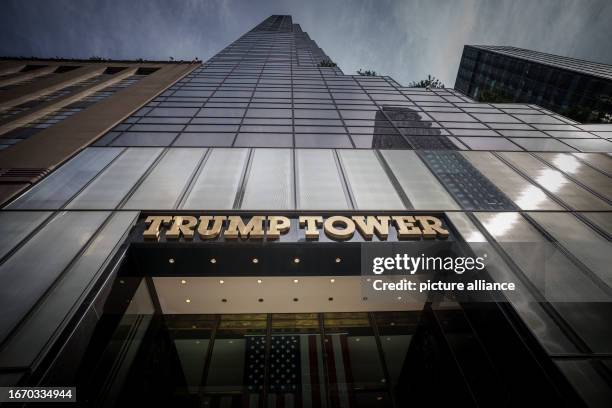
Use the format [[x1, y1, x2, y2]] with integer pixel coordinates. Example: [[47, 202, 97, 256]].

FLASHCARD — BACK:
[[0, 16, 612, 407]]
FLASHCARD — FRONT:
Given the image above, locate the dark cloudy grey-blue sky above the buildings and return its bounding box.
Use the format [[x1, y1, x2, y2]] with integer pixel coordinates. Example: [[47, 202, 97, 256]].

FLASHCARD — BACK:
[[0, 0, 612, 86]]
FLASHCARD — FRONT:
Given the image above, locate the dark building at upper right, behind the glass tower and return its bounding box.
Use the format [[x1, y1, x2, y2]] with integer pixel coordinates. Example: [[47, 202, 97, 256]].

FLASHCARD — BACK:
[[455, 45, 612, 123]]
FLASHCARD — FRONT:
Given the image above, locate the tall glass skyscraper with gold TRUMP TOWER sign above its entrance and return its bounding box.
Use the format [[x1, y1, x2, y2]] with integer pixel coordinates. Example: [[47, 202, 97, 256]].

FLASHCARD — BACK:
[[0, 15, 612, 407]]
